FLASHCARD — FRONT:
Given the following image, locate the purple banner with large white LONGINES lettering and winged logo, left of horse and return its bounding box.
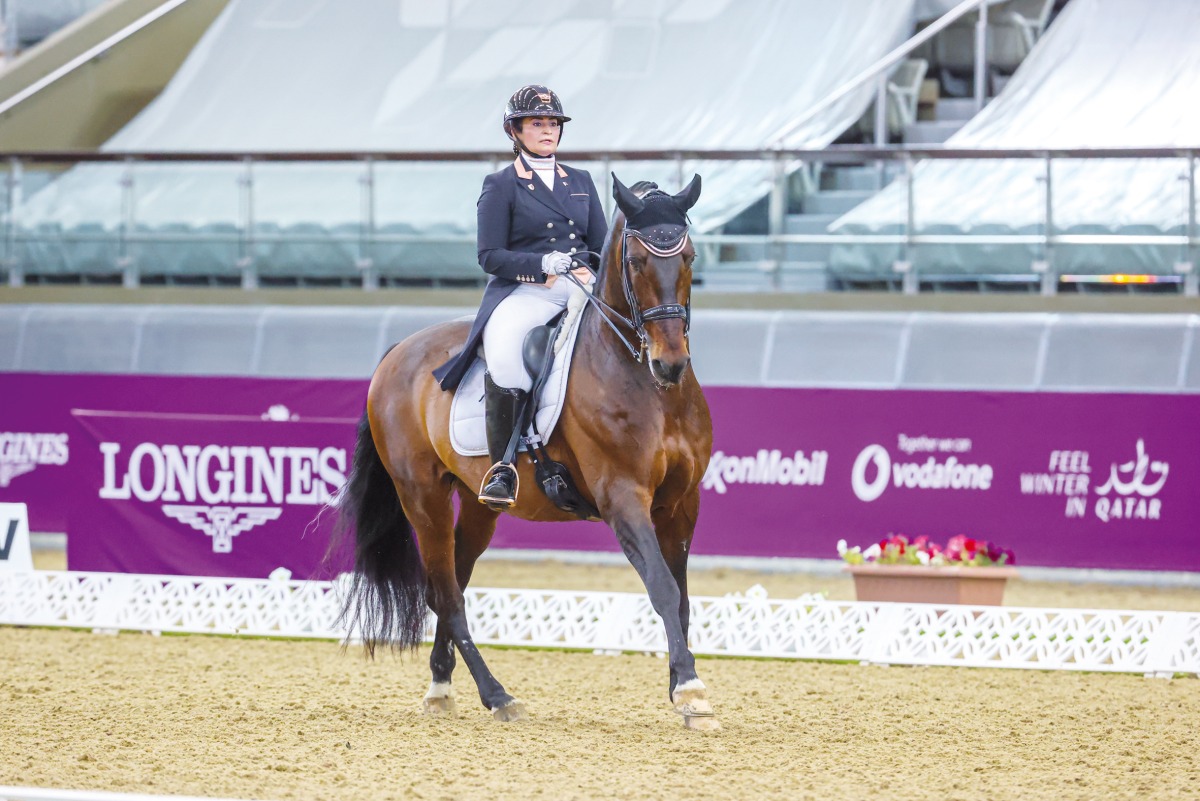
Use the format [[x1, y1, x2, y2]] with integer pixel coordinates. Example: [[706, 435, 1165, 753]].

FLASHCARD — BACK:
[[67, 409, 355, 578]]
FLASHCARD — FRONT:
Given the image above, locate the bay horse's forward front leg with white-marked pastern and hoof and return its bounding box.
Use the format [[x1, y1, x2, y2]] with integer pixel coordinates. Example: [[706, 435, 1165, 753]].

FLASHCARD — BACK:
[[602, 484, 720, 729]]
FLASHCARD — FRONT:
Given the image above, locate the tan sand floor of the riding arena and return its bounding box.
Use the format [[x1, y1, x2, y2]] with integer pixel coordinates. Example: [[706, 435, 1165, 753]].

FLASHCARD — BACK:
[[9, 554, 1200, 801]]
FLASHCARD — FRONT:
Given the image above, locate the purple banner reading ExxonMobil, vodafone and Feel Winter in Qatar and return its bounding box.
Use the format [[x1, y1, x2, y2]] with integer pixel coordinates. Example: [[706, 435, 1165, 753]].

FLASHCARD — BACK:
[[695, 387, 1200, 571]]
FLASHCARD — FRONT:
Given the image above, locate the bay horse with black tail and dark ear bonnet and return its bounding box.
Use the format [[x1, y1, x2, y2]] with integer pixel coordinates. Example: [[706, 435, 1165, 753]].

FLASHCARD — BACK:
[[338, 175, 719, 729]]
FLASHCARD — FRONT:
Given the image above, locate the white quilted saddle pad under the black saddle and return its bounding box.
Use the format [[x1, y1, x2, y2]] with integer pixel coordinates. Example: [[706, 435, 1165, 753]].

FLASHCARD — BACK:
[[450, 303, 583, 456]]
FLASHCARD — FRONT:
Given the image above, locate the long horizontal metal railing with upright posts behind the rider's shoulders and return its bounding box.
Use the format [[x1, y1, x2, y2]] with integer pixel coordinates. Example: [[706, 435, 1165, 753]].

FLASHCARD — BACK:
[[0, 145, 1200, 295]]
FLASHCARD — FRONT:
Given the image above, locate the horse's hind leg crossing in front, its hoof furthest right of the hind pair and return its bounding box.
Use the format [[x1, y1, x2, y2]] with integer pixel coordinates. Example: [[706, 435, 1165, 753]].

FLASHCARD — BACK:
[[402, 486, 526, 721]]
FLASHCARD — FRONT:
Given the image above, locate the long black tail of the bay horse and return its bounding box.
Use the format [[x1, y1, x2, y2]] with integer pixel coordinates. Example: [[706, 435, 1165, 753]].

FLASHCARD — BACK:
[[330, 414, 427, 656]]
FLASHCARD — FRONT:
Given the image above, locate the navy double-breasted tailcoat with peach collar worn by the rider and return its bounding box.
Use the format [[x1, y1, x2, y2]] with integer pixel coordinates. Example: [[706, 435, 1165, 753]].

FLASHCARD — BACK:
[[433, 156, 608, 390]]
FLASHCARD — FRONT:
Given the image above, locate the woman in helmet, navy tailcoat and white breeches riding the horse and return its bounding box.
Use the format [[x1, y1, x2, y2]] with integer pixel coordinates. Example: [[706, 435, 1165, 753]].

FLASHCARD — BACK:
[[433, 85, 608, 510]]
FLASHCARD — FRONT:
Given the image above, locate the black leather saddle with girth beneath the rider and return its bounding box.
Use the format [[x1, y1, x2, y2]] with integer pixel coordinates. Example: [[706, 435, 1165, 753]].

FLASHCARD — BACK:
[[504, 309, 600, 520]]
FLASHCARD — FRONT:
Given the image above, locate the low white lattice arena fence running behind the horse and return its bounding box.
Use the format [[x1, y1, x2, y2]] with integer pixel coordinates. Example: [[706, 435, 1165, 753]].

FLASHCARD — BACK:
[[0, 571, 1200, 677]]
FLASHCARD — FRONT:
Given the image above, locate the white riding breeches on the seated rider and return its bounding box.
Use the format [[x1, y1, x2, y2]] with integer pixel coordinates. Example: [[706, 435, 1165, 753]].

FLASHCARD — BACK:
[[484, 277, 575, 391]]
